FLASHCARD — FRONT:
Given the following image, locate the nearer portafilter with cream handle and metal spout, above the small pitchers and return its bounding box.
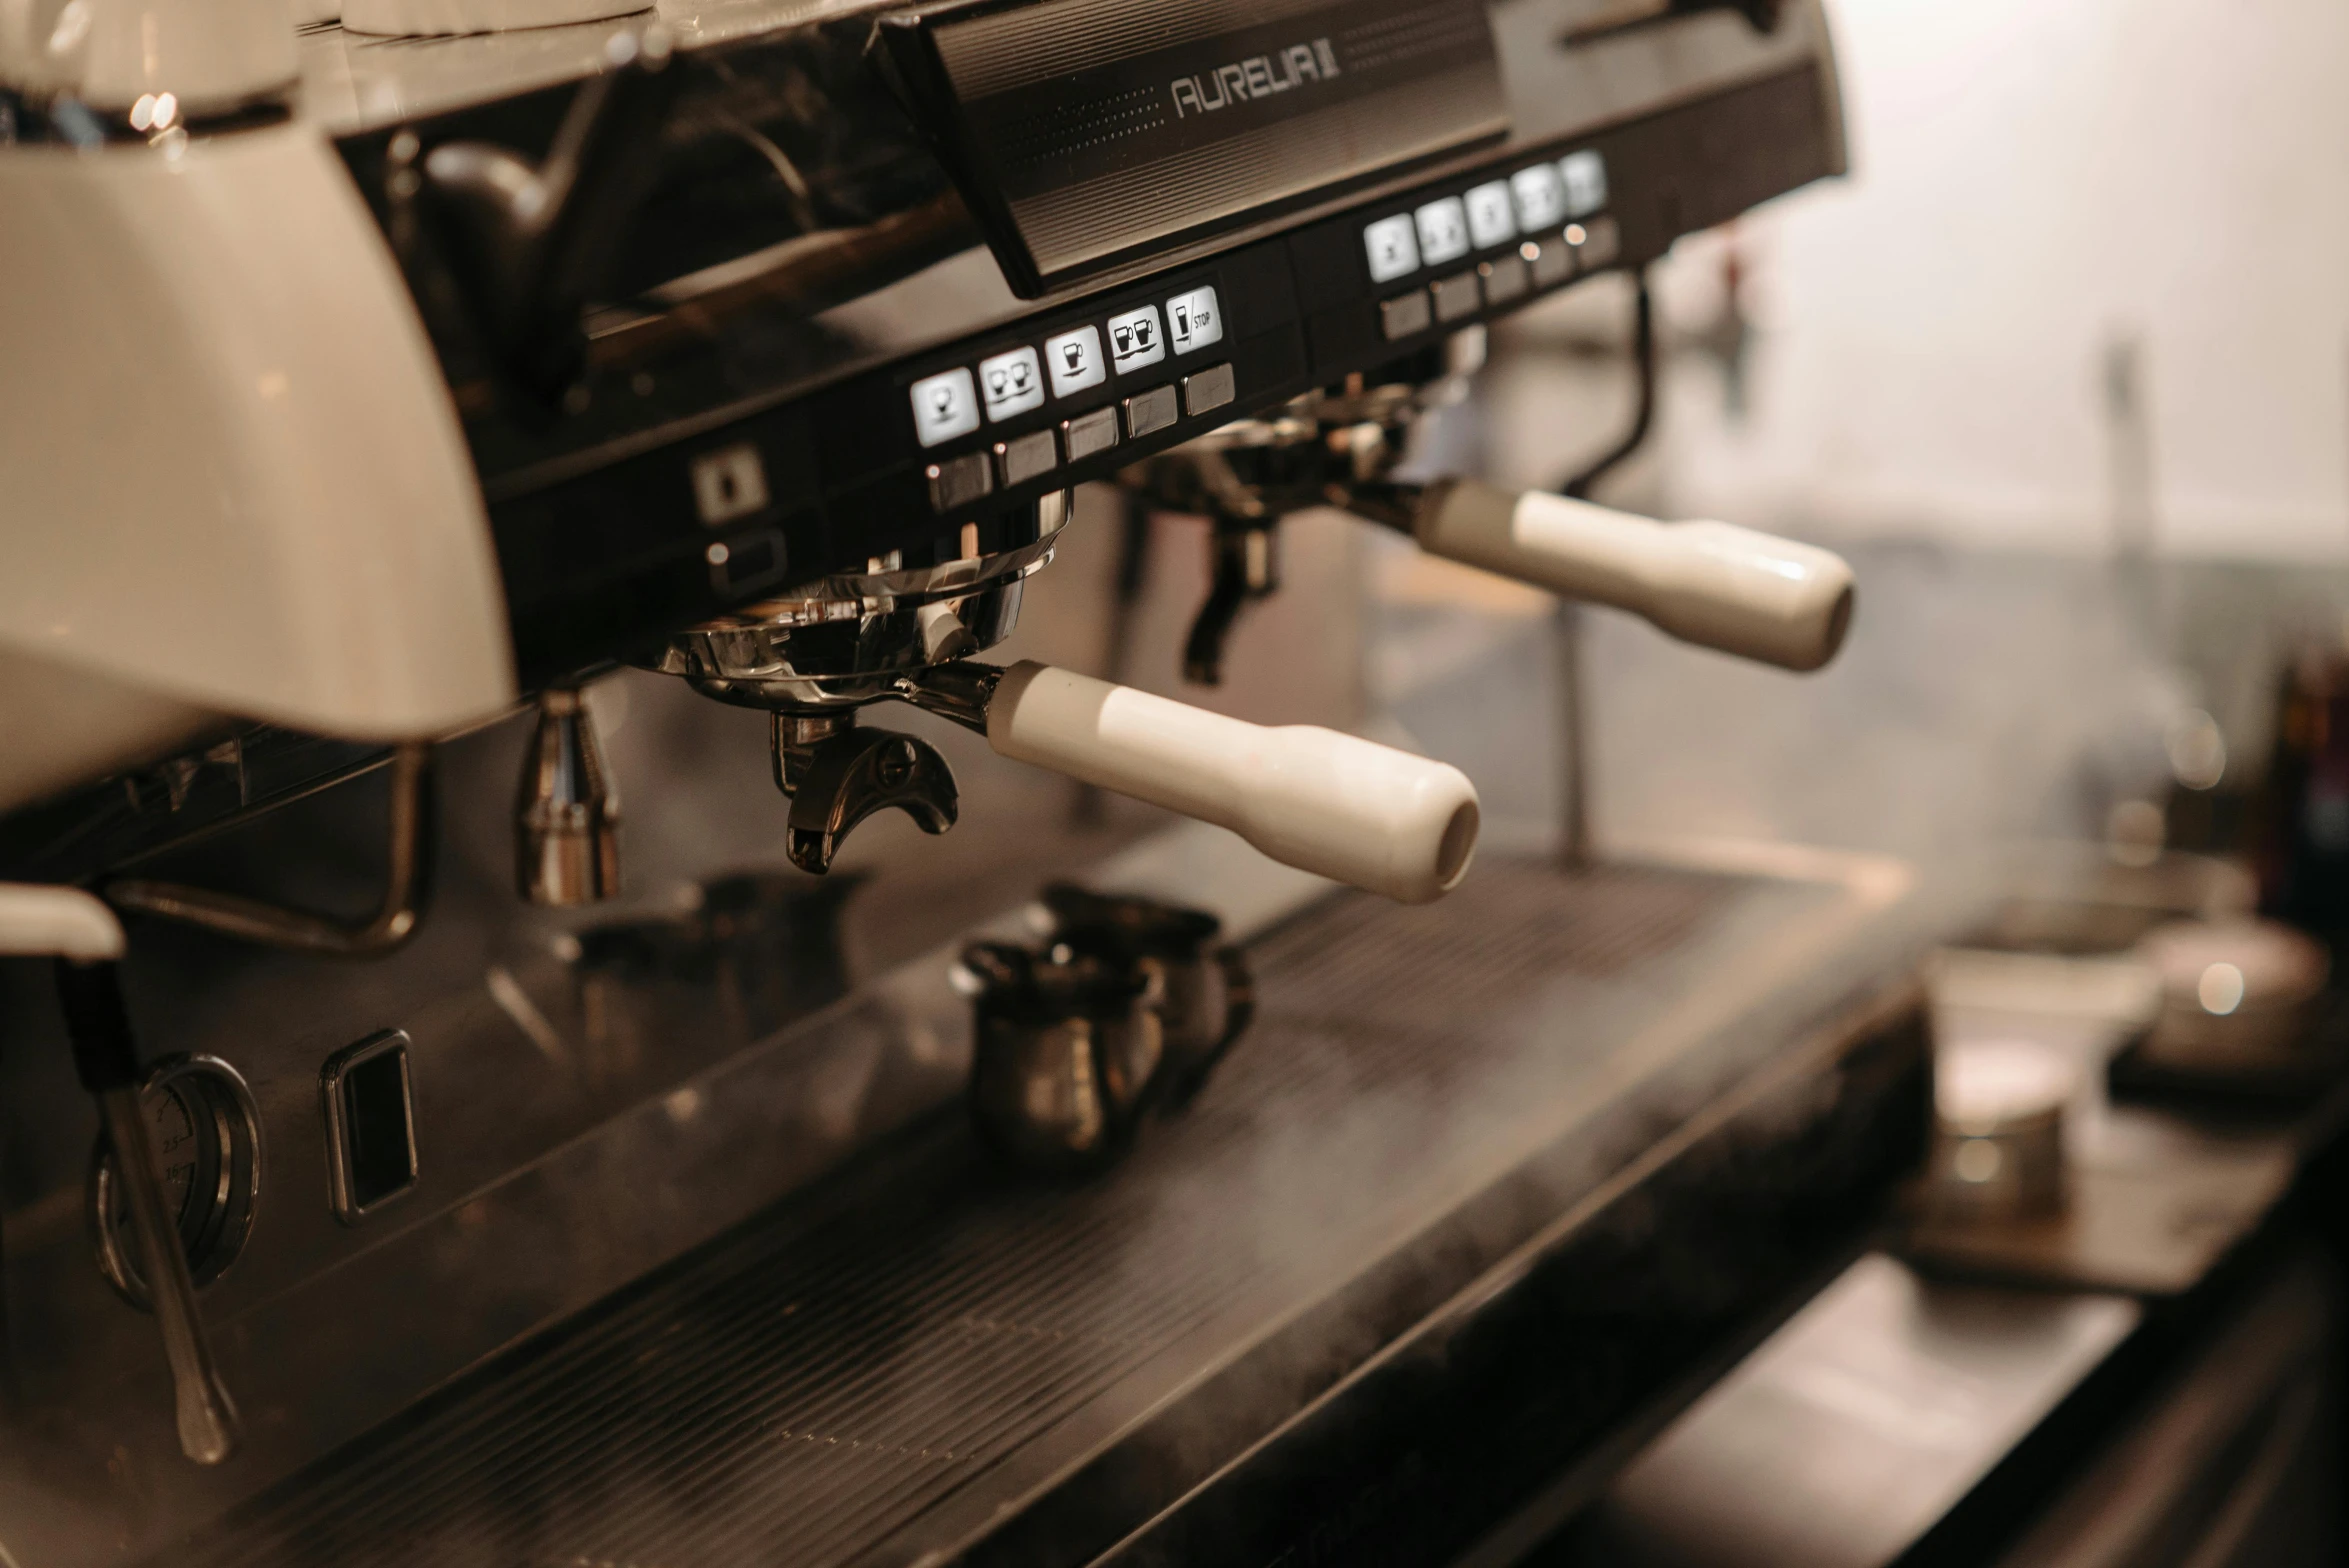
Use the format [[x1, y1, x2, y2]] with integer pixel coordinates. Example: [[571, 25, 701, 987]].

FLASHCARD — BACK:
[[653, 505, 1478, 904]]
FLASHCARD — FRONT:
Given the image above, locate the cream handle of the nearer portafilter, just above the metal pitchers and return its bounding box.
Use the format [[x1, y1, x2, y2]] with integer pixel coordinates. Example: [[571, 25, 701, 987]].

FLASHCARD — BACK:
[[987, 662, 1478, 904]]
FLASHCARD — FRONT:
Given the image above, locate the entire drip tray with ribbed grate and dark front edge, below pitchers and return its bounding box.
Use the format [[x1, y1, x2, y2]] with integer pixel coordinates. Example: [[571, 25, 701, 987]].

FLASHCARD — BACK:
[[171, 861, 1926, 1568]]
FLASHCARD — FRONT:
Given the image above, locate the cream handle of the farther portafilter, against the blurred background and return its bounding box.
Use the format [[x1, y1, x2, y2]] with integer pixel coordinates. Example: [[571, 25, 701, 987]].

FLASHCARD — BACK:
[[1412, 479, 1851, 669]]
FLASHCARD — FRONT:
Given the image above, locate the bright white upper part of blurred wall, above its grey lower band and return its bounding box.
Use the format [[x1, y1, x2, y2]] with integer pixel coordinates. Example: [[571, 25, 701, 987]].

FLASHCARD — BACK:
[[1658, 0, 2349, 561]]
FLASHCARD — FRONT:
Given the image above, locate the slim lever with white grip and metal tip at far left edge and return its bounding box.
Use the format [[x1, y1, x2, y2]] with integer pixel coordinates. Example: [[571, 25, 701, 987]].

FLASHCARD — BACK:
[[0, 883, 237, 1465]]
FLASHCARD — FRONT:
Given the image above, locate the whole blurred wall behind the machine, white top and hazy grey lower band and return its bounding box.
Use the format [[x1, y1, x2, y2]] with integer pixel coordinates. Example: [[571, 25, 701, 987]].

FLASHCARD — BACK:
[[1369, 0, 2349, 859]]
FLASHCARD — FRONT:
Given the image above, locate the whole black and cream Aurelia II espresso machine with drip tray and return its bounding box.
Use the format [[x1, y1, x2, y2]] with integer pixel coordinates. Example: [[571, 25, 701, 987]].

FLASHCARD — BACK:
[[0, 0, 1933, 1566]]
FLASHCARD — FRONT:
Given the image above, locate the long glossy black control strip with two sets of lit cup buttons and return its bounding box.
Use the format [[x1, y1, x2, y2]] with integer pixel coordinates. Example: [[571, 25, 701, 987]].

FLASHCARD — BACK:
[[476, 66, 1832, 681]]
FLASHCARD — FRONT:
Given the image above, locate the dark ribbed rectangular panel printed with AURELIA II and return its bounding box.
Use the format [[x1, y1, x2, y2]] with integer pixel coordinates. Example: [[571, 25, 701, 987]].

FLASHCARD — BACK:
[[888, 0, 1508, 298]]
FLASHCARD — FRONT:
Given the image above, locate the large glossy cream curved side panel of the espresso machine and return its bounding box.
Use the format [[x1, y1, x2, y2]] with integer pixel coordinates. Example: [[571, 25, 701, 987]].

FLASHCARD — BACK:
[[0, 124, 514, 788]]
